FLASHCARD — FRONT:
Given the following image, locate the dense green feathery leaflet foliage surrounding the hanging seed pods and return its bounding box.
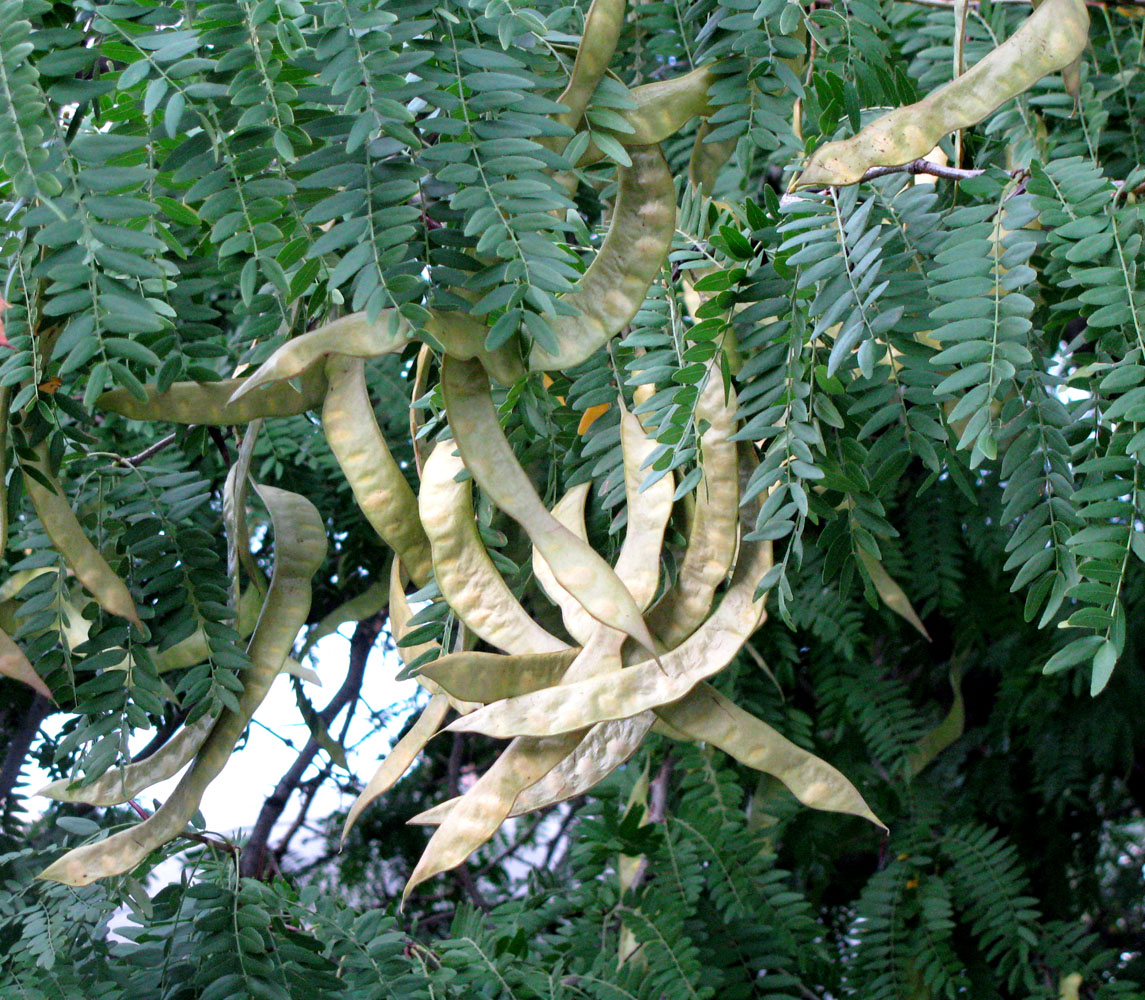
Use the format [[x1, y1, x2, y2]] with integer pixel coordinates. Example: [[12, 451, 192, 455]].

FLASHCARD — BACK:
[[0, 0, 1145, 1000]]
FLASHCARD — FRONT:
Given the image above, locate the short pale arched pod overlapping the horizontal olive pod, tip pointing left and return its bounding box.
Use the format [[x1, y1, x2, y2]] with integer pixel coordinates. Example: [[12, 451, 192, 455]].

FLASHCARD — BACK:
[[231, 310, 413, 401]]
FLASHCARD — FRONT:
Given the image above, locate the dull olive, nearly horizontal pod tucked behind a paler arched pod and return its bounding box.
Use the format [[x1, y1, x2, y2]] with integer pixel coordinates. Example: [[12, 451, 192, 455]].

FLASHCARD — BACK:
[[95, 369, 326, 427]]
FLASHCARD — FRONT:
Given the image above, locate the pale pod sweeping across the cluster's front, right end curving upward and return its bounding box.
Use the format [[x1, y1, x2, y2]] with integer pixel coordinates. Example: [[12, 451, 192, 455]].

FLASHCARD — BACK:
[[449, 542, 772, 739]]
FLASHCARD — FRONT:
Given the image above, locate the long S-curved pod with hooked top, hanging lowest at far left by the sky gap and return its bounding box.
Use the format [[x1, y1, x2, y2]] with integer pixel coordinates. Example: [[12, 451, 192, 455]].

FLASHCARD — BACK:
[[38, 487, 326, 885]]
